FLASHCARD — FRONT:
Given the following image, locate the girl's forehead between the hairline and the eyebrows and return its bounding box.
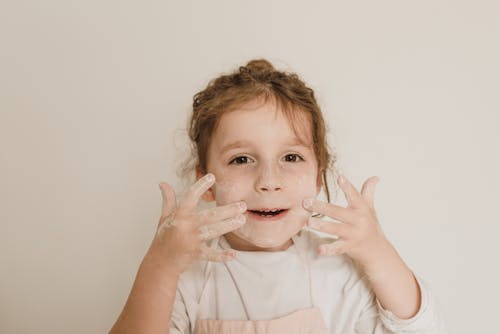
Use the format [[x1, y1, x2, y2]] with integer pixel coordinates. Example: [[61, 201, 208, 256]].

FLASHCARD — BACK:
[[212, 102, 312, 149]]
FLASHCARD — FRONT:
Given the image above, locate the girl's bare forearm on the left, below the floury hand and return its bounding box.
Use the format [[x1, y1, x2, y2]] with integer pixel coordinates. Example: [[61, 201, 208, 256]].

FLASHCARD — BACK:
[[110, 243, 179, 334]]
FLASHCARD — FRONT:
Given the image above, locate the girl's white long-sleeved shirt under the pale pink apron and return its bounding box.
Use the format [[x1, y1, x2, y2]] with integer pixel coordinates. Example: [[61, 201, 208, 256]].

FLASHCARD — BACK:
[[170, 229, 446, 334]]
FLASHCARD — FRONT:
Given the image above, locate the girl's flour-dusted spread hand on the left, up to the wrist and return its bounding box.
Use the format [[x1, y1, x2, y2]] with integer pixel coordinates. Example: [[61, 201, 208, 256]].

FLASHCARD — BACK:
[[152, 174, 246, 274]]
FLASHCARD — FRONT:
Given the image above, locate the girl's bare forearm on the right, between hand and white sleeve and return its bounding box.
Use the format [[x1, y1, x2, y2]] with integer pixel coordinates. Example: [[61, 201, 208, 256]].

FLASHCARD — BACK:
[[360, 241, 421, 319]]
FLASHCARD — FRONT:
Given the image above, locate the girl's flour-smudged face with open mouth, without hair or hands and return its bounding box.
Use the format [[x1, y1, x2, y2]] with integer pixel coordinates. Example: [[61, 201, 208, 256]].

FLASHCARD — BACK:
[[199, 102, 321, 250]]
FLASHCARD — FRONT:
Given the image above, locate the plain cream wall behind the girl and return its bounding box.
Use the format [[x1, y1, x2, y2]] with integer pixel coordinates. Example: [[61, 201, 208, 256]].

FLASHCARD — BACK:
[[0, 0, 500, 334]]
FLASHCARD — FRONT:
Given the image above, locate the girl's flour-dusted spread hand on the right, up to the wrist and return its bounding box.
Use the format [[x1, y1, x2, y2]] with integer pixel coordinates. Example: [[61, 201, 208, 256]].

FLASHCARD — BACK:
[[303, 176, 388, 262]]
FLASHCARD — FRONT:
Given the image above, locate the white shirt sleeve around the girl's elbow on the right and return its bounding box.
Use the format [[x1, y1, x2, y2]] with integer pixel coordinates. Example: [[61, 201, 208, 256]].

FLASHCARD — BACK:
[[356, 274, 447, 334]]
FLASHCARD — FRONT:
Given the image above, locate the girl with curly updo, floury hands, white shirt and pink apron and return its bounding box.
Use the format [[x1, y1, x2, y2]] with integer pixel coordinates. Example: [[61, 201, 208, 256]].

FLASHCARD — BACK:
[[111, 60, 444, 334]]
